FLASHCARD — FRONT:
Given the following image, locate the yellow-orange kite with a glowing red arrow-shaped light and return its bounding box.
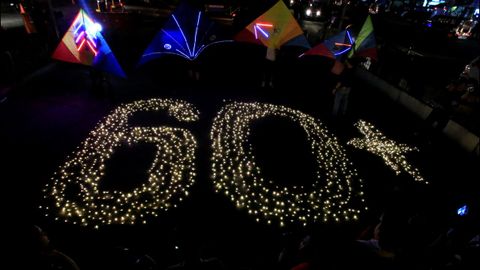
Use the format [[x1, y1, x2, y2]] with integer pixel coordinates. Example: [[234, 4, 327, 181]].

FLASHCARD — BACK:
[[235, 1, 310, 49]]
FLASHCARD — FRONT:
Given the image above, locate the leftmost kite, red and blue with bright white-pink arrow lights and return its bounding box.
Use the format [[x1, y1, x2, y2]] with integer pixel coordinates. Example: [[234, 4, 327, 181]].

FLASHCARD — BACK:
[[52, 9, 126, 77]]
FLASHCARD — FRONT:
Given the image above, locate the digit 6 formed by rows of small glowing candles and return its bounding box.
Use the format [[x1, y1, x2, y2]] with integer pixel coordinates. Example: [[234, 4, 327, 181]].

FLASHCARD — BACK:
[[41, 99, 199, 228]]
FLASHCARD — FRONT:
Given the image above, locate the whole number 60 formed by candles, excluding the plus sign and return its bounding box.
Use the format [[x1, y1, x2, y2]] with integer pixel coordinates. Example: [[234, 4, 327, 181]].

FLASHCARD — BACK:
[[45, 99, 402, 228]]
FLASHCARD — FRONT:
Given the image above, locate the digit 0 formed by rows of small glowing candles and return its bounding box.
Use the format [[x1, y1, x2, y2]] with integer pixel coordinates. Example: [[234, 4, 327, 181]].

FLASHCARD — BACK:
[[210, 103, 366, 226]]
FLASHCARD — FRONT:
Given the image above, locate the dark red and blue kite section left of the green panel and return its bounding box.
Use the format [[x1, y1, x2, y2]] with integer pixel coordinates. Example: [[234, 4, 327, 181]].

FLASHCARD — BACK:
[[301, 30, 353, 60]]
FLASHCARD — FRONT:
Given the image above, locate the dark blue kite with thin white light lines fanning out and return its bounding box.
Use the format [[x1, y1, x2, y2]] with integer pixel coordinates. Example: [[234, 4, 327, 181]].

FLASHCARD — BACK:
[[139, 2, 232, 65]]
